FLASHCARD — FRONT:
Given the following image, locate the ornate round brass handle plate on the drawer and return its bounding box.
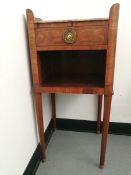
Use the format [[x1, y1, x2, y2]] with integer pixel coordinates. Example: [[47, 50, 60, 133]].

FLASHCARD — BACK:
[[64, 29, 76, 44]]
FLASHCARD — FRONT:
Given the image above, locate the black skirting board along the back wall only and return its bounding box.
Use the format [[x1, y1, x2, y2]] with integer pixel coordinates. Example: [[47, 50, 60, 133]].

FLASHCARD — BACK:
[[56, 118, 131, 135]]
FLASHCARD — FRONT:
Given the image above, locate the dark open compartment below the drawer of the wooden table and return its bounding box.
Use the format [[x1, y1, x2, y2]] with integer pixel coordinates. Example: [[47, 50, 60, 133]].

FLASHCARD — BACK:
[[38, 50, 106, 87]]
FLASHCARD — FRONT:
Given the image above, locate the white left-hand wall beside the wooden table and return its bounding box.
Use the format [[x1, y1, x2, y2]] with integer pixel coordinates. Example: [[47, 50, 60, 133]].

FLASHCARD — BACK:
[[0, 0, 51, 175]]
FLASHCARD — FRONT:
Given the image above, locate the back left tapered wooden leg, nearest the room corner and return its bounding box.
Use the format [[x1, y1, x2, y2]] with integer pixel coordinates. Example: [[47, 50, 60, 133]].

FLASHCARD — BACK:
[[51, 93, 56, 130]]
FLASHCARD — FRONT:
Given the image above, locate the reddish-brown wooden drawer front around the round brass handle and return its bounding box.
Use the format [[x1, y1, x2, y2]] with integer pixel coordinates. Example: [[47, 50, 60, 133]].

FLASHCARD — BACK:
[[36, 26, 107, 47]]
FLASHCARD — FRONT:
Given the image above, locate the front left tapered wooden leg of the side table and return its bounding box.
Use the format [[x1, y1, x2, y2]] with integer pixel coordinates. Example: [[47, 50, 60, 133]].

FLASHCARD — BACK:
[[35, 93, 46, 161]]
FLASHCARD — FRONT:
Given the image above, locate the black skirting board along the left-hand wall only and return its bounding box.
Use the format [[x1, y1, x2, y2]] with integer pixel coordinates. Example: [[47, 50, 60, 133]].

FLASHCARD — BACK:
[[23, 120, 53, 175]]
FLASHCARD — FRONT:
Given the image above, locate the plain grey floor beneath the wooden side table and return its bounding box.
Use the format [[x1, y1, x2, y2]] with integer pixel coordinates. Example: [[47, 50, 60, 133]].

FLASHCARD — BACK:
[[36, 130, 131, 175]]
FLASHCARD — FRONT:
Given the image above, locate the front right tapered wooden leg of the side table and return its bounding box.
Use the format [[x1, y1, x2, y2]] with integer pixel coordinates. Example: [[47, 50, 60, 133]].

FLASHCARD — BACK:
[[100, 95, 112, 169]]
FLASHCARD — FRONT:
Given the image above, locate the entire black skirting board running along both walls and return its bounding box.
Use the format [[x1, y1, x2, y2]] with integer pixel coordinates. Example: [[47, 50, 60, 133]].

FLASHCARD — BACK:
[[23, 118, 131, 175]]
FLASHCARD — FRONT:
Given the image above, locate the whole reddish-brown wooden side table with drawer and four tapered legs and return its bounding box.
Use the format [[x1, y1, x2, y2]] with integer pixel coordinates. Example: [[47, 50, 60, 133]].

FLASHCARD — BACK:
[[26, 4, 119, 168]]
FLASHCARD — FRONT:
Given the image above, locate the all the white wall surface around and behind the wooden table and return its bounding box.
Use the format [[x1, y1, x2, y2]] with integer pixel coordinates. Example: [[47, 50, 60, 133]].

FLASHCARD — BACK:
[[0, 0, 131, 175]]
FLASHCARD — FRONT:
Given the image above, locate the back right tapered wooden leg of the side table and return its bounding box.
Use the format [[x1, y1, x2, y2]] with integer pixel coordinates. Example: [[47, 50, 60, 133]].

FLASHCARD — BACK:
[[96, 95, 102, 134]]
